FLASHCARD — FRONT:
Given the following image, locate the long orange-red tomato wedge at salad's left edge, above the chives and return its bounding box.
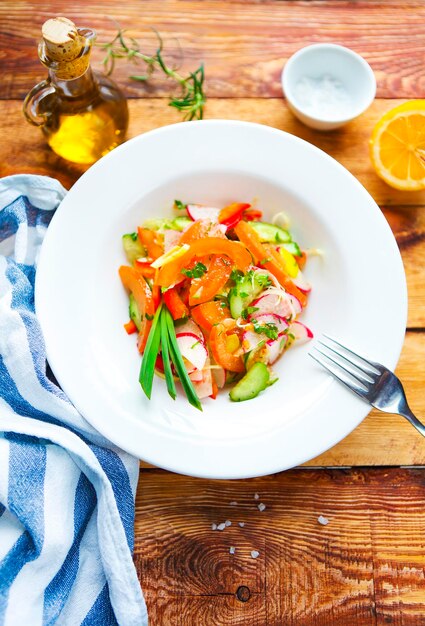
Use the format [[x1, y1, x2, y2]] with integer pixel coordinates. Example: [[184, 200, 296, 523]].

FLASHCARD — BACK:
[[118, 265, 155, 354]]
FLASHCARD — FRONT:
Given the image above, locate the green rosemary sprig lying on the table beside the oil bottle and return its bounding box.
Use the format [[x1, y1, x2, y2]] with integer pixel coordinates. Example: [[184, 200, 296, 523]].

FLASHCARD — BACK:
[[100, 27, 206, 121]]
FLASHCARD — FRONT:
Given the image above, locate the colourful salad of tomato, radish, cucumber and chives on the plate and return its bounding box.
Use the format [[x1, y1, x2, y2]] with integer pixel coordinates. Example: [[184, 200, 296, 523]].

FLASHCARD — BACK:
[[119, 200, 313, 410]]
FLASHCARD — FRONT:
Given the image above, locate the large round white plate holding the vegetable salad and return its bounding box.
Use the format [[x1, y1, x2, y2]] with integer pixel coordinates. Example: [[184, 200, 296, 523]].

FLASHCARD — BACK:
[[36, 120, 407, 478]]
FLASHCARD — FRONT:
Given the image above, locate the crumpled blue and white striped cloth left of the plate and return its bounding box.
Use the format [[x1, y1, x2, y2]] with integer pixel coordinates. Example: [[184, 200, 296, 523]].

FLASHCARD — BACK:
[[0, 175, 148, 626]]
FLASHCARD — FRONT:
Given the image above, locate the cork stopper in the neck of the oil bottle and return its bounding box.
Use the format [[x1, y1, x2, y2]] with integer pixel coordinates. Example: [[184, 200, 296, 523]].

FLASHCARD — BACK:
[[40, 17, 94, 80]]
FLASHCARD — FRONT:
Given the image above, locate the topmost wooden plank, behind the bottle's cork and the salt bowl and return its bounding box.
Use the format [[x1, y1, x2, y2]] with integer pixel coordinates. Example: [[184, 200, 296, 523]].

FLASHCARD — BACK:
[[0, 0, 425, 98]]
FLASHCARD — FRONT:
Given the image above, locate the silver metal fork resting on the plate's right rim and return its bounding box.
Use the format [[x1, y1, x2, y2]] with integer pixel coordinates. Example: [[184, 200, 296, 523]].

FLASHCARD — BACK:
[[309, 335, 425, 437]]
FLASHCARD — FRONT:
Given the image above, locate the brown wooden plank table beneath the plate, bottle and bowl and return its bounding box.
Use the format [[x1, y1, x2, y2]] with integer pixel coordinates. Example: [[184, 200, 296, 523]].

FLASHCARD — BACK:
[[0, 0, 425, 626]]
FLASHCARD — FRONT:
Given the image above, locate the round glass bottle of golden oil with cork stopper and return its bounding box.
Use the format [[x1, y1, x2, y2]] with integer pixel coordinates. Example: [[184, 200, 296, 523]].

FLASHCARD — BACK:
[[24, 17, 128, 164]]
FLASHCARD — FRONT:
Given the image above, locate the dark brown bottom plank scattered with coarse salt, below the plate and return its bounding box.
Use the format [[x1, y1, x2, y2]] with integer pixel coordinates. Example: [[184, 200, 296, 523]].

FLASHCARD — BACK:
[[134, 469, 425, 626]]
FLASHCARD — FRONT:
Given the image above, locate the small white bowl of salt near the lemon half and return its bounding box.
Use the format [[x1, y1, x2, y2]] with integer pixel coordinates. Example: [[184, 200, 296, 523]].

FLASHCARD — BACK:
[[282, 43, 376, 130]]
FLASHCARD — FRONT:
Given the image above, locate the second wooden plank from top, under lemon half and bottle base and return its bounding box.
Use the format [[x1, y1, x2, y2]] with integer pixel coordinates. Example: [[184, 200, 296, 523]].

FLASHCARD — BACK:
[[0, 98, 425, 207]]
